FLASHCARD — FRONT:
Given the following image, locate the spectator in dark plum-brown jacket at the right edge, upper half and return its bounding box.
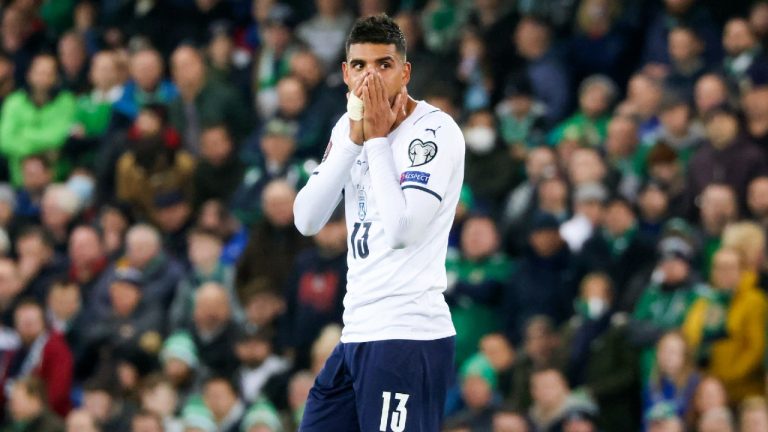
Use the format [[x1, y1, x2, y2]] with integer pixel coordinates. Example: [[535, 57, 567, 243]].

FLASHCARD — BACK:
[[686, 104, 768, 213]]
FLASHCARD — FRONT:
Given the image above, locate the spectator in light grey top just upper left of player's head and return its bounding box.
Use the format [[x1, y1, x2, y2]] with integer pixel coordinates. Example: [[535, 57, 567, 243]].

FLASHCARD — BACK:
[[296, 0, 354, 70]]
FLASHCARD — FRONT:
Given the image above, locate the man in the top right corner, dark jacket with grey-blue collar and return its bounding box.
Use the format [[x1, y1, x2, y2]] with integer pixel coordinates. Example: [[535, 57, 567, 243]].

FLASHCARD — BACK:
[[723, 17, 764, 85]]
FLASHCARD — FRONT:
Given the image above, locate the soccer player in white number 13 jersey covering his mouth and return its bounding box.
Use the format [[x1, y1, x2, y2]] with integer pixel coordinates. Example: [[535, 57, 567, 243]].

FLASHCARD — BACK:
[[294, 15, 464, 432]]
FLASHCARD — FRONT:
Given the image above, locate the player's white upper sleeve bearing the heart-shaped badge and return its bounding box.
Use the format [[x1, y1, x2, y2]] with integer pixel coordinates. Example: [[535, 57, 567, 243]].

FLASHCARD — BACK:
[[395, 112, 464, 201]]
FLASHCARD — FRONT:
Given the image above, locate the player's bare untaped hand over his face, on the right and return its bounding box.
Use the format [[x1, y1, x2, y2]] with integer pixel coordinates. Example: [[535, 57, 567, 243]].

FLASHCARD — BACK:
[[362, 73, 407, 140]]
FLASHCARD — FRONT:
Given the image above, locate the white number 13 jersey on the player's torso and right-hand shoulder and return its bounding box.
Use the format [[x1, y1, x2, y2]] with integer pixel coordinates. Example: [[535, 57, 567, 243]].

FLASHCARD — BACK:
[[331, 101, 464, 342]]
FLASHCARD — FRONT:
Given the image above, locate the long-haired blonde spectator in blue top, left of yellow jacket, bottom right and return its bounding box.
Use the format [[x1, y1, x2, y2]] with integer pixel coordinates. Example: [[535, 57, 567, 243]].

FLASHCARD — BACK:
[[643, 330, 701, 428]]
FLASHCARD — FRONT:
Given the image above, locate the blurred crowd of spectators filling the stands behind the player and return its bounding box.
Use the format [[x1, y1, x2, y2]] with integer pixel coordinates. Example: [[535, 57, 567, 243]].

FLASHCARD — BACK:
[[6, 0, 768, 432]]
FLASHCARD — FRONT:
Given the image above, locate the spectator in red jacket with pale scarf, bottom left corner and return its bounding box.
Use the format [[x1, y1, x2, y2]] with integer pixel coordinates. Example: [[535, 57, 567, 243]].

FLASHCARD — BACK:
[[7, 301, 73, 420]]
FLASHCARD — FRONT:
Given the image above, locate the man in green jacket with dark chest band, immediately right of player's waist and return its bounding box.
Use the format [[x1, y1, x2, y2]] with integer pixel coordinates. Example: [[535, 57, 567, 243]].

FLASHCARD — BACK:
[[445, 216, 512, 364]]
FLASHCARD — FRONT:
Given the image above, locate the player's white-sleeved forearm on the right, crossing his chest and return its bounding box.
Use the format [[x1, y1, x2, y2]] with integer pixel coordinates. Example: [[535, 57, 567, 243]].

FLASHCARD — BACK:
[[365, 138, 440, 249]]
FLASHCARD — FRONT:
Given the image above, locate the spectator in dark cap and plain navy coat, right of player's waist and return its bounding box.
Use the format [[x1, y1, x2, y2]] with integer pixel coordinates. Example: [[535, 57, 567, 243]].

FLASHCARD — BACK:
[[502, 212, 573, 342]]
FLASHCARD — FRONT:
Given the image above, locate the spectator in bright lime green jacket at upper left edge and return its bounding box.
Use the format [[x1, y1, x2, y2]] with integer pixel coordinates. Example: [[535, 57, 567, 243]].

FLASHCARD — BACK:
[[0, 54, 75, 186]]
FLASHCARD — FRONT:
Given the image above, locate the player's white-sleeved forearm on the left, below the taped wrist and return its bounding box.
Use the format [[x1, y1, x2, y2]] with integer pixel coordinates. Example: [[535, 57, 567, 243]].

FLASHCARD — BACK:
[[293, 137, 362, 236]]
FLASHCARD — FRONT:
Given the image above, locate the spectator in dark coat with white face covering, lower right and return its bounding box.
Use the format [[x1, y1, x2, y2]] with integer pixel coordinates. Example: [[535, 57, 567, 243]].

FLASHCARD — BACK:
[[560, 273, 639, 431]]
